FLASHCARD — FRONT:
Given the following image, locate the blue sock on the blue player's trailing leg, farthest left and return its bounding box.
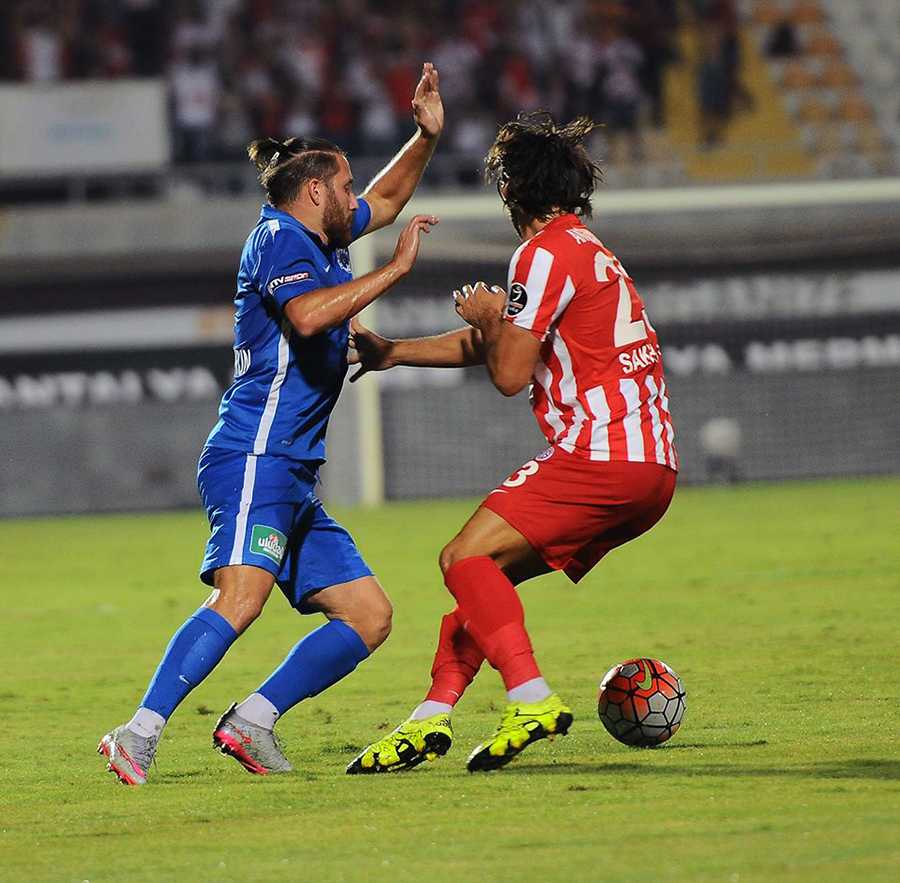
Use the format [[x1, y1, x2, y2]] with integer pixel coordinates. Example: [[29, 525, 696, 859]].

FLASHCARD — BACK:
[[141, 607, 237, 720]]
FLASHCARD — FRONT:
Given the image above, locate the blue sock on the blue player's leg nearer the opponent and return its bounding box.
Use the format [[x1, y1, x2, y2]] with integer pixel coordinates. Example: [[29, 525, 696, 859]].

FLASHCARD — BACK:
[[256, 619, 369, 714]]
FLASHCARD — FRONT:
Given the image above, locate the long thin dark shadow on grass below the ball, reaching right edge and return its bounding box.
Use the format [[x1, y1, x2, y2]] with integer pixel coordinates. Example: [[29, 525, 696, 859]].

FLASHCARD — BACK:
[[503, 758, 900, 781]]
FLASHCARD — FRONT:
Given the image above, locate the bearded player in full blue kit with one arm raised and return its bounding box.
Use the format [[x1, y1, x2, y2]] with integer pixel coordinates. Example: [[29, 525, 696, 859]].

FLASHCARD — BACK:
[[98, 64, 444, 785]]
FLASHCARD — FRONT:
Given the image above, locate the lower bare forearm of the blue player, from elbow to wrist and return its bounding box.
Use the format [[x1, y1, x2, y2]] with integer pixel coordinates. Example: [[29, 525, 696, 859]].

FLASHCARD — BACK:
[[284, 260, 406, 337]]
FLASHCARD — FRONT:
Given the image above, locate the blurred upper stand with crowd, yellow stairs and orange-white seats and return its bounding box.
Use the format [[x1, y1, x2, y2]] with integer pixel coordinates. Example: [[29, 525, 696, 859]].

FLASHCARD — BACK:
[[0, 0, 900, 201]]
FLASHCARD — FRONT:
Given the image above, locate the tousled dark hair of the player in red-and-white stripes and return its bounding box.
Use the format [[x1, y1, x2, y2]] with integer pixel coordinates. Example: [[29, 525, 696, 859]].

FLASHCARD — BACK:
[[484, 110, 603, 224]]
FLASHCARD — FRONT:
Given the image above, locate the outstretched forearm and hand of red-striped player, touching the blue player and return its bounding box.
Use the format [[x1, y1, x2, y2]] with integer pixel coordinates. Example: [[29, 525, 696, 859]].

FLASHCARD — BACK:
[[348, 319, 484, 383]]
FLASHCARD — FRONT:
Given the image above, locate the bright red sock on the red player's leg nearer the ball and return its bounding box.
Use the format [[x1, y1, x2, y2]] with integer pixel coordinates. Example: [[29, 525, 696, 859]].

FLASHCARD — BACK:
[[440, 556, 541, 692]]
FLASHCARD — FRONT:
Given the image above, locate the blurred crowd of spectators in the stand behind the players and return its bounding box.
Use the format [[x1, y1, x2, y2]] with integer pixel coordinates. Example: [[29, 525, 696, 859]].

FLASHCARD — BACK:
[[0, 0, 696, 162]]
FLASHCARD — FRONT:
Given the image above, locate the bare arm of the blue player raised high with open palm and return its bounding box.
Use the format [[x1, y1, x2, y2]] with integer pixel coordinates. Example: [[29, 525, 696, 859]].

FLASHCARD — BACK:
[[362, 62, 444, 233]]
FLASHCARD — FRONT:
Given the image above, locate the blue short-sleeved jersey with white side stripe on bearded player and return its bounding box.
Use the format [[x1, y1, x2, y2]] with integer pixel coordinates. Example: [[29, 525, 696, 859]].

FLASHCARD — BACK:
[[207, 199, 372, 461]]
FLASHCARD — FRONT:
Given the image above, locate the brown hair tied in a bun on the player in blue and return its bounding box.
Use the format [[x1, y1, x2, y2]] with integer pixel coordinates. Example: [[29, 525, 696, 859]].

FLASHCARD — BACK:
[[247, 138, 344, 208]]
